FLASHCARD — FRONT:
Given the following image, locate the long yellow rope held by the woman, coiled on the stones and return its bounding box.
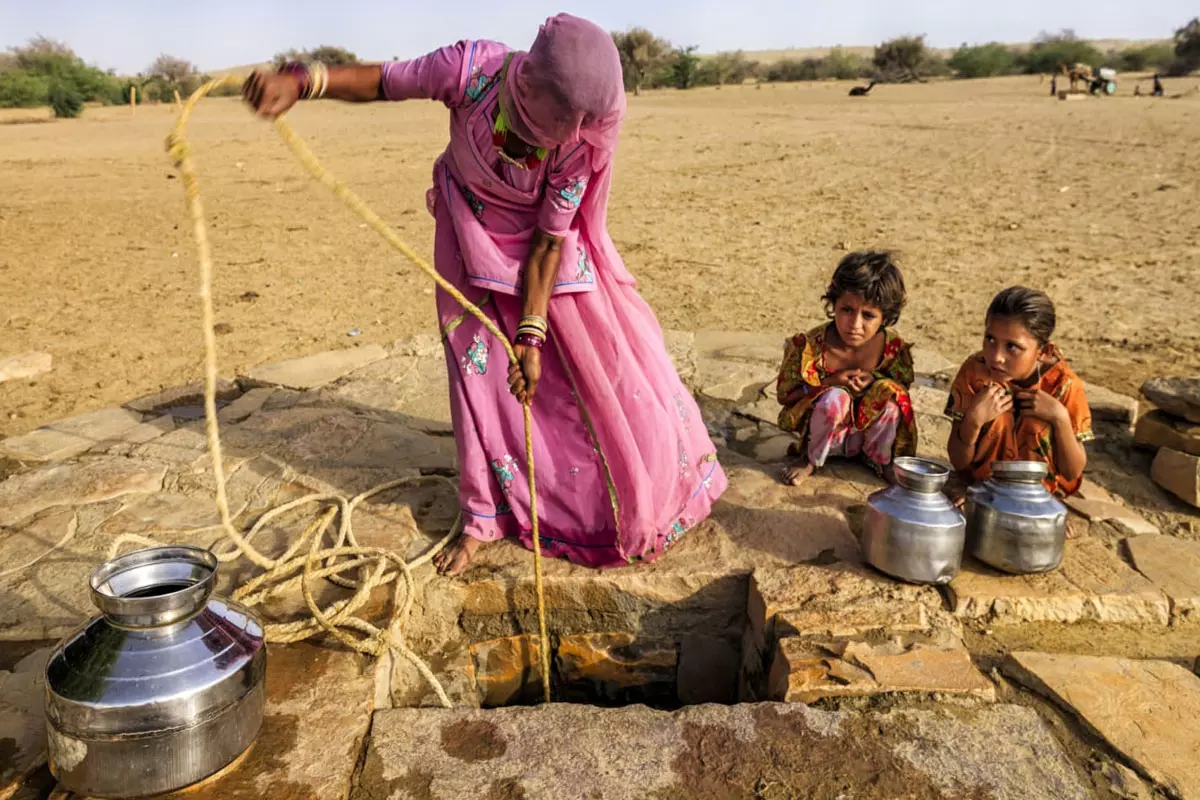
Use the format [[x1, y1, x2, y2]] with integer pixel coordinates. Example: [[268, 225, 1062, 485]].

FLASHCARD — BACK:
[[160, 76, 550, 708]]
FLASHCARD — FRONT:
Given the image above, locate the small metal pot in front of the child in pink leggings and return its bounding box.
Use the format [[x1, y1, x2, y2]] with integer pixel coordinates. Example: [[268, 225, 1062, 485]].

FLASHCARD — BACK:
[[863, 458, 966, 584]]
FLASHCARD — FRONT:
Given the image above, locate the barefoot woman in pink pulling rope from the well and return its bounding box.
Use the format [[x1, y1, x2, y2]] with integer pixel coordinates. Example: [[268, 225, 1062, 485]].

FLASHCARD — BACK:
[[244, 14, 726, 575]]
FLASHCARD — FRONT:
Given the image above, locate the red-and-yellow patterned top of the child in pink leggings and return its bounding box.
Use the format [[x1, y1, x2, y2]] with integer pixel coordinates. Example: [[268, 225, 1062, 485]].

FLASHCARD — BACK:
[[775, 324, 917, 457]]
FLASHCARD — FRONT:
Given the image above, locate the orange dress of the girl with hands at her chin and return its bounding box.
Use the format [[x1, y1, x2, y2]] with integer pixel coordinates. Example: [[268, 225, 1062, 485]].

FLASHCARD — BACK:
[[946, 353, 1094, 495]]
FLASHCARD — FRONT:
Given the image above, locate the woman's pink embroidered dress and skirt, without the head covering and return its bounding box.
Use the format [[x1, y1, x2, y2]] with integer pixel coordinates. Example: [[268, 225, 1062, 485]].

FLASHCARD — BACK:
[[383, 29, 726, 566]]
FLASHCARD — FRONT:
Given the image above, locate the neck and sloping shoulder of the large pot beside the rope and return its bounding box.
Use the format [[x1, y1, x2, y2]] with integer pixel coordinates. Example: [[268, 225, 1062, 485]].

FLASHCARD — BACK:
[[46, 547, 266, 738]]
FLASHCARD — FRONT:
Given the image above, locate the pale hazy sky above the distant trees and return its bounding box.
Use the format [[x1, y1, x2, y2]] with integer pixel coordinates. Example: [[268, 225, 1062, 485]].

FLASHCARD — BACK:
[[0, 0, 1198, 73]]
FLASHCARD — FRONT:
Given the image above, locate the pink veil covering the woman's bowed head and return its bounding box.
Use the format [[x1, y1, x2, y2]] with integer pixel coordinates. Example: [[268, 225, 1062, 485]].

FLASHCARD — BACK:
[[504, 14, 625, 154]]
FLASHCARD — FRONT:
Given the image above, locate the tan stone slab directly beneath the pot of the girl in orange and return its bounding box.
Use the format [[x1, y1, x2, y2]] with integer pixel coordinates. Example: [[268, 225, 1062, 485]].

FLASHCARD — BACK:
[[947, 537, 1170, 625]]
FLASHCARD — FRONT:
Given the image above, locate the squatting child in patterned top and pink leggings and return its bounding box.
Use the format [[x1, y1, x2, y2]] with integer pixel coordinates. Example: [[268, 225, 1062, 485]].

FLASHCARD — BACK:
[[775, 252, 917, 486]]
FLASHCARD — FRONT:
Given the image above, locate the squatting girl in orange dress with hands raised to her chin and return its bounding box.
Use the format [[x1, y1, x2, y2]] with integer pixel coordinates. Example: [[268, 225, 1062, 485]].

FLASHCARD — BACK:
[[946, 287, 1093, 500]]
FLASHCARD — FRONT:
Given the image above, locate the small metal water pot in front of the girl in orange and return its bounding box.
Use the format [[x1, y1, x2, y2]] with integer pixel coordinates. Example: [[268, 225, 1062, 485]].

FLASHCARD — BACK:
[[967, 461, 1067, 575]]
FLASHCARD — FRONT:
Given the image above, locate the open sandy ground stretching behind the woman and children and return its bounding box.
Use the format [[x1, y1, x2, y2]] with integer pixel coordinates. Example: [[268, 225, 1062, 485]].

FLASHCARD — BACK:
[[0, 78, 1200, 434]]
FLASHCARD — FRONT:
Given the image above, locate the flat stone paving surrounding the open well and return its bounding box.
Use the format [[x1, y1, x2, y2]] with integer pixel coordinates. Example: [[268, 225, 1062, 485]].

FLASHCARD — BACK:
[[0, 333, 1200, 799]]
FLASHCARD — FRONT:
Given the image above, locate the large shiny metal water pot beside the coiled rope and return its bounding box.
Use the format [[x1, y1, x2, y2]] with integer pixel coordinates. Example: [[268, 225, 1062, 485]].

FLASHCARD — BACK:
[[46, 547, 266, 798]]
